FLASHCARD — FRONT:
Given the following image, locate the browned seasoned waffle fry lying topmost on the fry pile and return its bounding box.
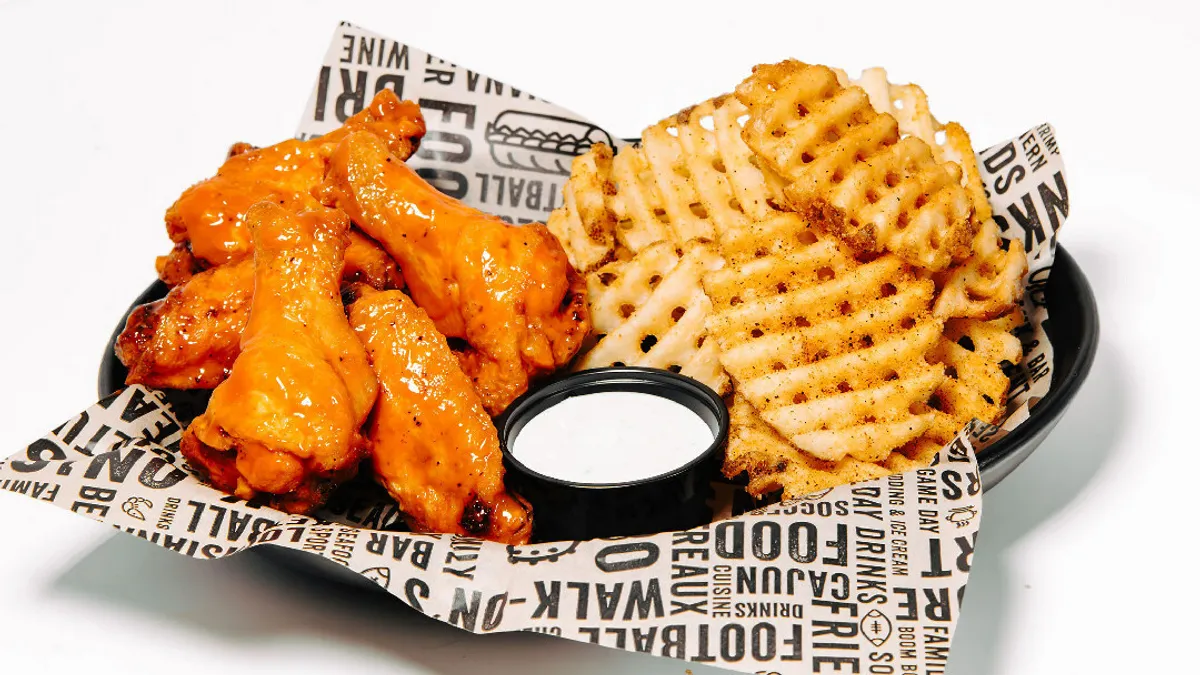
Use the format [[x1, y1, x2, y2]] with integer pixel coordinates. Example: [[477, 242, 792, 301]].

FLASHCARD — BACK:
[[737, 61, 978, 271]]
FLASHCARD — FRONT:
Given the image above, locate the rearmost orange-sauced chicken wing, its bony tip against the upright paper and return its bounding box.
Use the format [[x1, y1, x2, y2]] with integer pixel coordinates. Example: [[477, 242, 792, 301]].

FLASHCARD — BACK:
[[155, 89, 425, 279]]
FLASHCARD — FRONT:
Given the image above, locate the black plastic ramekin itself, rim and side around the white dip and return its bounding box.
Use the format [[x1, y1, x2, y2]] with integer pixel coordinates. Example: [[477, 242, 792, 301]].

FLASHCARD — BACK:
[[496, 368, 730, 542]]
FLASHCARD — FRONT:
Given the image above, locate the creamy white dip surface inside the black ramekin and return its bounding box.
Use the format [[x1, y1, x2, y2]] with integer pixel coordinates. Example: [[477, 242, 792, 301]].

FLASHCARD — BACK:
[[511, 392, 714, 484]]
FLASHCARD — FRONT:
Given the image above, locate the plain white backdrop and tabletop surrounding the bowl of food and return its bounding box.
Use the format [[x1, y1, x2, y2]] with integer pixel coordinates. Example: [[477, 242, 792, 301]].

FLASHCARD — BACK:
[[0, 0, 1200, 675]]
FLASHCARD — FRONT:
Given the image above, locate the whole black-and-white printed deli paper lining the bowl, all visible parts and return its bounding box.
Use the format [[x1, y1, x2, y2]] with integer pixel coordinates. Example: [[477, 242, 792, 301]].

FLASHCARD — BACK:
[[0, 25, 1067, 673]]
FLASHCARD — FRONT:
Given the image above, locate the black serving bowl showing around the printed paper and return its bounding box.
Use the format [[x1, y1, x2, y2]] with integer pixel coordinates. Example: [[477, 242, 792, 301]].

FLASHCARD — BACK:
[[97, 246, 1100, 589]]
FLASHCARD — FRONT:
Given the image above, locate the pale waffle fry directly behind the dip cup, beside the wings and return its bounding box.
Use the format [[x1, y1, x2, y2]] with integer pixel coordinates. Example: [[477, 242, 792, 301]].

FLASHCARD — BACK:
[[578, 240, 728, 393]]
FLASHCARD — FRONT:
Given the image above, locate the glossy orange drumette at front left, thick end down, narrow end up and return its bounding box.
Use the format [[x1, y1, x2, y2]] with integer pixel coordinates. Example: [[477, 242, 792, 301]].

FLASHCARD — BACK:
[[181, 202, 378, 513]]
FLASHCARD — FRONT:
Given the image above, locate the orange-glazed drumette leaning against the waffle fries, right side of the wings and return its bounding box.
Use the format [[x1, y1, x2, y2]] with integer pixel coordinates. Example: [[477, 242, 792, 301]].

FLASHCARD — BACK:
[[319, 133, 590, 416]]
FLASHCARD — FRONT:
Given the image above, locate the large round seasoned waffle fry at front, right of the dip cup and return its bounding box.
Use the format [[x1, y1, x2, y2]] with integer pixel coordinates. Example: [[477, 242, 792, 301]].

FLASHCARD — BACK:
[[704, 214, 946, 462]]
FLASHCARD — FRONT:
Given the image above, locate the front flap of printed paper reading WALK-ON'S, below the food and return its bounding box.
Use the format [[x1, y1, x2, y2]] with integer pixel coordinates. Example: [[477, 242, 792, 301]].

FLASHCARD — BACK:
[[0, 386, 982, 673]]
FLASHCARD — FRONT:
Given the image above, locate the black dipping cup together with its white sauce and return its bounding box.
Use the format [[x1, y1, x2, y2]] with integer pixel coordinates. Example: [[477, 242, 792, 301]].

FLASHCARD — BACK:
[[497, 368, 730, 542]]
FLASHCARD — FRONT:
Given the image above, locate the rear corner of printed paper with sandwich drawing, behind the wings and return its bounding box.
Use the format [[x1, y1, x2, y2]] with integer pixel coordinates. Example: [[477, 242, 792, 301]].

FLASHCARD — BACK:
[[296, 24, 622, 222]]
